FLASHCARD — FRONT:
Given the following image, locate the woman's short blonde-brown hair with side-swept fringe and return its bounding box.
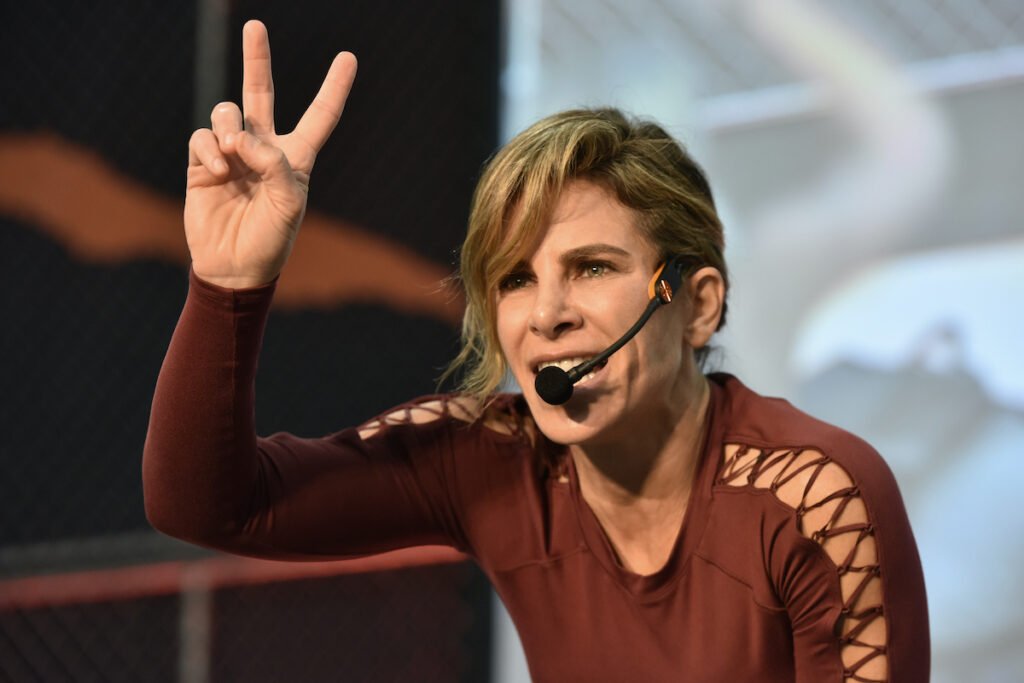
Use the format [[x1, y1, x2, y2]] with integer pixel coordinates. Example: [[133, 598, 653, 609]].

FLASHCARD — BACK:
[[442, 108, 728, 398]]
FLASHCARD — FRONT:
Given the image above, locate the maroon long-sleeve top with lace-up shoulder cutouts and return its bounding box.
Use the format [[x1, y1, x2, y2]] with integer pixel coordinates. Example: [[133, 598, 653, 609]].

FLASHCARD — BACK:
[[143, 275, 930, 683]]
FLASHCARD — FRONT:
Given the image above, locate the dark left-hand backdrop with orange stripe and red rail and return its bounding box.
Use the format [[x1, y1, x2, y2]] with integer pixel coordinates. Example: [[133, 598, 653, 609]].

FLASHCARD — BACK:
[[0, 0, 499, 681]]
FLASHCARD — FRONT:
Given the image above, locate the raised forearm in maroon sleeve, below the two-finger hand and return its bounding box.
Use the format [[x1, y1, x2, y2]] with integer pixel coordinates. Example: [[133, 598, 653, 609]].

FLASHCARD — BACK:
[[142, 266, 273, 545]]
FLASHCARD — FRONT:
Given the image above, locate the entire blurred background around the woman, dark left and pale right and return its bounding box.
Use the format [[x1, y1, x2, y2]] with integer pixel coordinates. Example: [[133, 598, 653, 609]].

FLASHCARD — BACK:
[[0, 0, 1024, 683]]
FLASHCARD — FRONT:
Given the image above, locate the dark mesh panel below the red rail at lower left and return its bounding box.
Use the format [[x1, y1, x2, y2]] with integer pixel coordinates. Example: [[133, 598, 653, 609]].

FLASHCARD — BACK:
[[0, 562, 488, 683]]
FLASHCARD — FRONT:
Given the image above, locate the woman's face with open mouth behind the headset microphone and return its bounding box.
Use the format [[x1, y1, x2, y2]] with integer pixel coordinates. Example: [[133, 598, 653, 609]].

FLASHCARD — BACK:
[[497, 181, 692, 444]]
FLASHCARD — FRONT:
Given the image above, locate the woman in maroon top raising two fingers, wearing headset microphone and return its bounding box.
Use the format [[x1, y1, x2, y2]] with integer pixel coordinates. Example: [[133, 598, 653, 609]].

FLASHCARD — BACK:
[[143, 18, 929, 682]]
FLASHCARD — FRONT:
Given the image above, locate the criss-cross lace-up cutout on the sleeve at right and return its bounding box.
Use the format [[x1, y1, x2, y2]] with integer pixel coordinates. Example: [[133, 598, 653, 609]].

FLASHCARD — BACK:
[[720, 444, 889, 683]]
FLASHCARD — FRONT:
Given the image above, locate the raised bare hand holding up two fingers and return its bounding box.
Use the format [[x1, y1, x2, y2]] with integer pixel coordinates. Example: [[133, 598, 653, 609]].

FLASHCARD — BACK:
[[184, 20, 355, 288]]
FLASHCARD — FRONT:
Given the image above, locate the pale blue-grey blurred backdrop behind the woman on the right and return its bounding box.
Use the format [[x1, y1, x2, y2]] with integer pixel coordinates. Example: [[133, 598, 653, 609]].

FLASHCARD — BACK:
[[495, 0, 1024, 683]]
